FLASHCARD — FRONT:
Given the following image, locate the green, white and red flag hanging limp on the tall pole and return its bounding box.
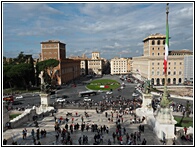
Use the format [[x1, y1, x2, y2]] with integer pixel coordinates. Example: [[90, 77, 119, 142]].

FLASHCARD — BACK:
[[164, 18, 169, 74]]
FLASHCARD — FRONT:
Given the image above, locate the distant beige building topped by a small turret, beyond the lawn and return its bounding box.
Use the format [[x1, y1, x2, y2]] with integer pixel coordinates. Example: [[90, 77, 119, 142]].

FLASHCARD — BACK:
[[88, 52, 104, 75]]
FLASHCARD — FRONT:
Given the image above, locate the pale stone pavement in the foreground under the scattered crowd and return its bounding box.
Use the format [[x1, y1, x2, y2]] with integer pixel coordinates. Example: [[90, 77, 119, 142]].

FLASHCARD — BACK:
[[3, 109, 192, 145]]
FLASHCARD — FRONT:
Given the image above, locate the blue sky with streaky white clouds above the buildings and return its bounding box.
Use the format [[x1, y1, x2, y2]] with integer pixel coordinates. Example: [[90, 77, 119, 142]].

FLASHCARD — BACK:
[[2, 2, 193, 59]]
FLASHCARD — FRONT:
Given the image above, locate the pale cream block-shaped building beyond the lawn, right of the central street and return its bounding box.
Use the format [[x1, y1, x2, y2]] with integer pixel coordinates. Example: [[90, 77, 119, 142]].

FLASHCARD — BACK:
[[110, 57, 132, 75]]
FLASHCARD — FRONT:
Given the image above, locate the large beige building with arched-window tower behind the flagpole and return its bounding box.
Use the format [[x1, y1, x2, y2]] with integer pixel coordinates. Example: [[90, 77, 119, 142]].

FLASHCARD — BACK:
[[132, 33, 193, 85]]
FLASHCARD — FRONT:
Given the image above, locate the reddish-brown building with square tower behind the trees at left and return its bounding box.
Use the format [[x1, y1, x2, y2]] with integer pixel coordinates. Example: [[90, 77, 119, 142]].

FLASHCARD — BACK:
[[41, 40, 80, 85]]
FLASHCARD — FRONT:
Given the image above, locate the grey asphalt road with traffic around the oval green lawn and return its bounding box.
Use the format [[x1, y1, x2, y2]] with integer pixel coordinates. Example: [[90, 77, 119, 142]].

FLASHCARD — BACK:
[[10, 75, 193, 111]]
